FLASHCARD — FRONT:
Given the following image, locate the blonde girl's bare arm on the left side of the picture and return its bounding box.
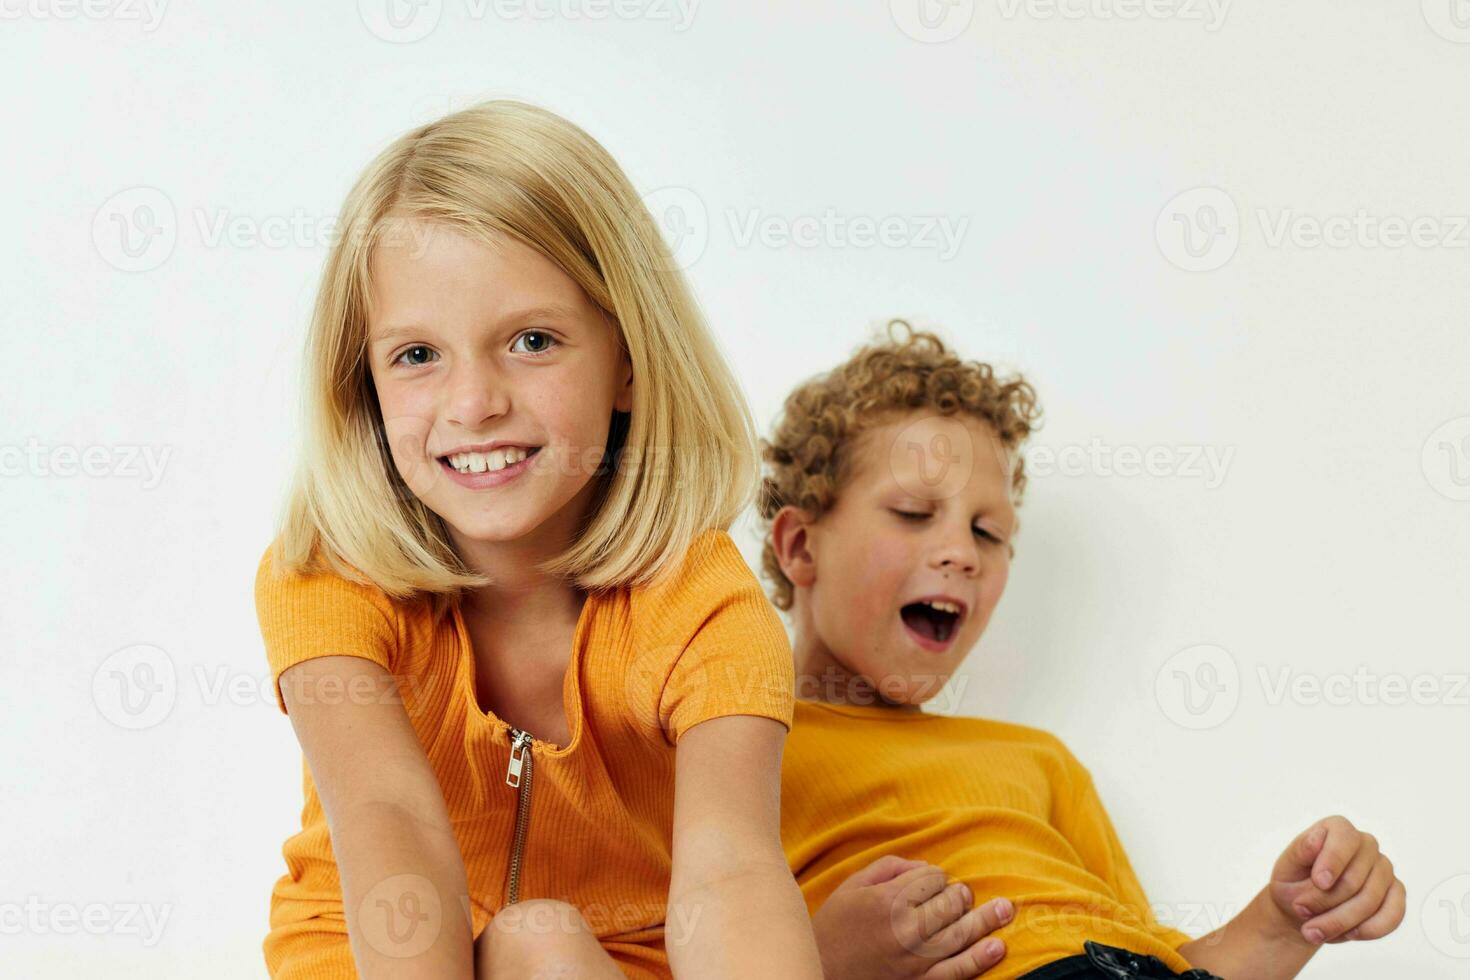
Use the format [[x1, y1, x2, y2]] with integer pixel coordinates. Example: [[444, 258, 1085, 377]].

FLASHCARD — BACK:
[[281, 657, 473, 980]]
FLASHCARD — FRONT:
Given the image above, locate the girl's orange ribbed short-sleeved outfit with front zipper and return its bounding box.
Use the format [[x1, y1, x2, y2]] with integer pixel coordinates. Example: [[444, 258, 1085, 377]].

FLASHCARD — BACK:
[[256, 529, 794, 980]]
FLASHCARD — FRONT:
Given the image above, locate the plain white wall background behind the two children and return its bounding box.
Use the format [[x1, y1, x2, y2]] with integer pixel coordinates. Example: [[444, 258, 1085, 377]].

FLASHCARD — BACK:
[[0, 0, 1470, 980]]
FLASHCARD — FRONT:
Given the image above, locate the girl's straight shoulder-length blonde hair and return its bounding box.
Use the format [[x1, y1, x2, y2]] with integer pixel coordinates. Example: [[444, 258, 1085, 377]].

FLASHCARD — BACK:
[[275, 100, 760, 613]]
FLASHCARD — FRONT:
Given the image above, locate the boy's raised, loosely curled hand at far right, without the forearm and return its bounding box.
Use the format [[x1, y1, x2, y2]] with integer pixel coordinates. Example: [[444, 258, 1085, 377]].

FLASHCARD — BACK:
[[1269, 817, 1405, 946]]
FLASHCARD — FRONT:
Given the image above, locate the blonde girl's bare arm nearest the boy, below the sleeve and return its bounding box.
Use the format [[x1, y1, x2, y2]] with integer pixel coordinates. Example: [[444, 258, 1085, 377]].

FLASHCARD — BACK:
[[664, 714, 822, 980]]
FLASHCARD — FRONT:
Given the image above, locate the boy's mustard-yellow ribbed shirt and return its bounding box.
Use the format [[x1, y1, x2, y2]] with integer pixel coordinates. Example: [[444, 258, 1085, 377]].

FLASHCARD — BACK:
[[781, 701, 1191, 980]]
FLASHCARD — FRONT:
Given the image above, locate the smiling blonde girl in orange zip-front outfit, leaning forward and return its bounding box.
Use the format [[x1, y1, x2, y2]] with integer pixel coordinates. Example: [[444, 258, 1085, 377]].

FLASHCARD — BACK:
[[256, 101, 820, 980]]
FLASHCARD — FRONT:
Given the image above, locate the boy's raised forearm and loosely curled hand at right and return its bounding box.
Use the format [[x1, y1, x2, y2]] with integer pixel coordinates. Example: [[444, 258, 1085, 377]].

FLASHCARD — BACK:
[[1179, 817, 1405, 980]]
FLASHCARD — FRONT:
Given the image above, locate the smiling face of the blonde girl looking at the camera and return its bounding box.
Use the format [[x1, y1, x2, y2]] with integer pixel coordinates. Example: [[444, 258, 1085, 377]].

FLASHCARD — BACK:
[[368, 222, 632, 551]]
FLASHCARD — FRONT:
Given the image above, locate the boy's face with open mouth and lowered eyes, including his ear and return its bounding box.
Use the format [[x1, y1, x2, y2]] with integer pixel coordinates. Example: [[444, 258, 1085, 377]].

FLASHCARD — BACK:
[[772, 413, 1016, 705]]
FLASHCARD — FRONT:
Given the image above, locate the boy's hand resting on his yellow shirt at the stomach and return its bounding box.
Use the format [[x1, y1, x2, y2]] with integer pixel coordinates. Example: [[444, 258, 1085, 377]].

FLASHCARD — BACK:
[[811, 854, 1014, 980]]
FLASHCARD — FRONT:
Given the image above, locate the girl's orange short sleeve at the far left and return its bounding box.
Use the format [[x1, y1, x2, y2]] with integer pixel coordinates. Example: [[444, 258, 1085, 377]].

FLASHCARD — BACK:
[[256, 547, 398, 713]]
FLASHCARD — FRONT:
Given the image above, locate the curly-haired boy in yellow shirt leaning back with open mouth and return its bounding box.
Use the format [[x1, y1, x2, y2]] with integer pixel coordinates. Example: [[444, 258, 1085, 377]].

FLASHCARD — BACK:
[[761, 322, 1404, 980]]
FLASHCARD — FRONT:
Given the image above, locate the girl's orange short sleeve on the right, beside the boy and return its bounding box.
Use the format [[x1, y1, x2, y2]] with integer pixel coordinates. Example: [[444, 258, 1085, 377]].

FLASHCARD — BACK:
[[651, 529, 795, 745]]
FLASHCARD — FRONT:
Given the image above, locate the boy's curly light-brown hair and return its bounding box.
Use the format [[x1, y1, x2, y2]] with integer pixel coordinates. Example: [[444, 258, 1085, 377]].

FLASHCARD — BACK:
[[759, 319, 1041, 610]]
